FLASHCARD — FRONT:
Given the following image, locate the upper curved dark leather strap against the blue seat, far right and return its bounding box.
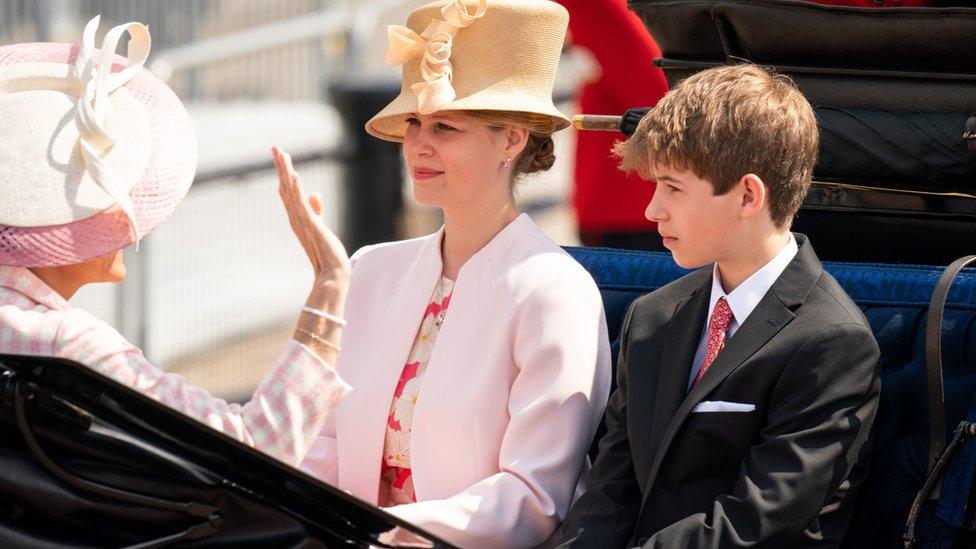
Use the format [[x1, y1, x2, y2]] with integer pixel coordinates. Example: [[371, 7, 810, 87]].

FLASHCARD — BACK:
[[925, 255, 976, 472]]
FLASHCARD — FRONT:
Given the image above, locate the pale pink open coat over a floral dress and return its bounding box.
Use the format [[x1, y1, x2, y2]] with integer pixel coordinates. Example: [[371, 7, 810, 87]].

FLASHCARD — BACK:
[[301, 214, 610, 548]]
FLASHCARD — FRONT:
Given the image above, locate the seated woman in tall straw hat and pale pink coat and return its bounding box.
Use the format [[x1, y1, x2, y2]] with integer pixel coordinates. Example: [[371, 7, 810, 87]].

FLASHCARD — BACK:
[[277, 0, 610, 547]]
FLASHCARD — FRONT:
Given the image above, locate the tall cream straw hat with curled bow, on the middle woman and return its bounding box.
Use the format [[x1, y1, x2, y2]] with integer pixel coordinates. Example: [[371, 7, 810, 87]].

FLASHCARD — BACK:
[[366, 0, 569, 141]]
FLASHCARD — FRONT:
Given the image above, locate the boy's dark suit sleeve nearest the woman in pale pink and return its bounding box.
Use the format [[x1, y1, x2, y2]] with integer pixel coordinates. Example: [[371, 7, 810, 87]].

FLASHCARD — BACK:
[[544, 304, 641, 548]]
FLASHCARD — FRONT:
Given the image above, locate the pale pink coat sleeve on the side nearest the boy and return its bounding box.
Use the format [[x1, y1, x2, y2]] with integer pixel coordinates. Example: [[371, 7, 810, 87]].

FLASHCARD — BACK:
[[388, 271, 610, 547]]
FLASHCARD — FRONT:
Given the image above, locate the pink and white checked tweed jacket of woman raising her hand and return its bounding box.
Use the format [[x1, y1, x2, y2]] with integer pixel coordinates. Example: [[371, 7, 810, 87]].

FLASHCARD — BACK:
[[0, 266, 350, 466]]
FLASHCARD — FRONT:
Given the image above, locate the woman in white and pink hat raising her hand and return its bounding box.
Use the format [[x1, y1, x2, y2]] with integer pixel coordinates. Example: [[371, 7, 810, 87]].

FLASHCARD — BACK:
[[0, 17, 349, 465]]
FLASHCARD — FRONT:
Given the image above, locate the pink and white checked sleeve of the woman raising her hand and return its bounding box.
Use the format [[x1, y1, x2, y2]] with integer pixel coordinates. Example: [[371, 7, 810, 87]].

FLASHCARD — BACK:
[[53, 309, 349, 466]]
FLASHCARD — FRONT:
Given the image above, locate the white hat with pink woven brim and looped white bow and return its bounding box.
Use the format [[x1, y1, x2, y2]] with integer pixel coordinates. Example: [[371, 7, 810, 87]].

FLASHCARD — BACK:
[[0, 17, 197, 267]]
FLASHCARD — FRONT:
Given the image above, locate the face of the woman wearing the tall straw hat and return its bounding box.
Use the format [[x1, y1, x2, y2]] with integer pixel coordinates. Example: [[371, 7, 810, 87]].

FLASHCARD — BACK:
[[403, 111, 528, 208]]
